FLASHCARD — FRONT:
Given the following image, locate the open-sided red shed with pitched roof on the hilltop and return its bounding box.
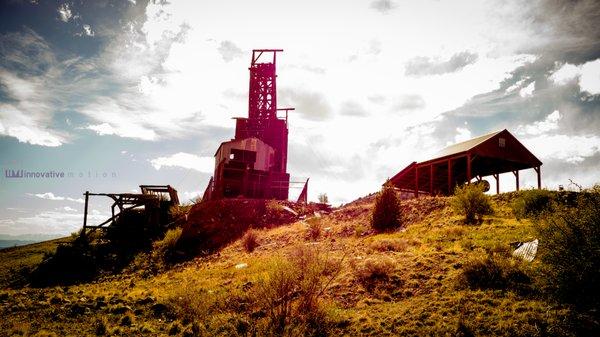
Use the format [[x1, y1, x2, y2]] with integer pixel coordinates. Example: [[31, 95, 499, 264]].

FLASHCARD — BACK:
[[387, 129, 542, 197]]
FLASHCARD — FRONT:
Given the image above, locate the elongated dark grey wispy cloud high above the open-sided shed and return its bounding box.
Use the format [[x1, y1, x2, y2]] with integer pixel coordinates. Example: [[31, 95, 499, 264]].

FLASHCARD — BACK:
[[404, 51, 478, 77]]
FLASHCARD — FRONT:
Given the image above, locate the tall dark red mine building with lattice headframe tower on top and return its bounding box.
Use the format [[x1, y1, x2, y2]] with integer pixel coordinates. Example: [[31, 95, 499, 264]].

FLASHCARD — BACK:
[[203, 49, 294, 200]]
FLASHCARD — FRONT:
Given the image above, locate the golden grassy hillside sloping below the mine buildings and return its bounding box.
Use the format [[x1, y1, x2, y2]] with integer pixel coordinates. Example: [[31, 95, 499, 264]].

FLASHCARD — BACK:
[[0, 193, 592, 336]]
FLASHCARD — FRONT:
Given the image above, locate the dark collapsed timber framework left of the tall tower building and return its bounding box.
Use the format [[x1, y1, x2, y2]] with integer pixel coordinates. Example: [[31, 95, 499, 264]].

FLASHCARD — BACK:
[[80, 185, 179, 237]]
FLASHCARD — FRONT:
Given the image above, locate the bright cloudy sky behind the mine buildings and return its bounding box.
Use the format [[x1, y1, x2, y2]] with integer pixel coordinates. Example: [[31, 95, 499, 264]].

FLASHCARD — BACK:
[[0, 0, 600, 237]]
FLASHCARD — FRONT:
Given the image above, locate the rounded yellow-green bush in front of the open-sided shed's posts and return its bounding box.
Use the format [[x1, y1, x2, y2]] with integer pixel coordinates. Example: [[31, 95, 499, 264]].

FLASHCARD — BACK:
[[450, 184, 492, 225]]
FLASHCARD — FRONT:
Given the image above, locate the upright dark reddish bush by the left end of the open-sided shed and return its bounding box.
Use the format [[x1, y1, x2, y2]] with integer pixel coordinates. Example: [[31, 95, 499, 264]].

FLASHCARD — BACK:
[[371, 185, 402, 232]]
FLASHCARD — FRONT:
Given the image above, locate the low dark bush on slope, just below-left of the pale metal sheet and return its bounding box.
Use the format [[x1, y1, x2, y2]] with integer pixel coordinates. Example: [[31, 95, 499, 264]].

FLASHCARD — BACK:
[[459, 254, 531, 290]]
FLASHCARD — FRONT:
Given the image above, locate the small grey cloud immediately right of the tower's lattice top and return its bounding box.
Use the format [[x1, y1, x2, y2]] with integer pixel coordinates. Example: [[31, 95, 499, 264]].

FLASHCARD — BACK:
[[277, 89, 331, 121]]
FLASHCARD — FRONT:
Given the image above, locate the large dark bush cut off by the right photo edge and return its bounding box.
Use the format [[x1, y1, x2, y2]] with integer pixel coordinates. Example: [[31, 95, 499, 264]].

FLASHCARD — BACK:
[[537, 185, 600, 310]]
